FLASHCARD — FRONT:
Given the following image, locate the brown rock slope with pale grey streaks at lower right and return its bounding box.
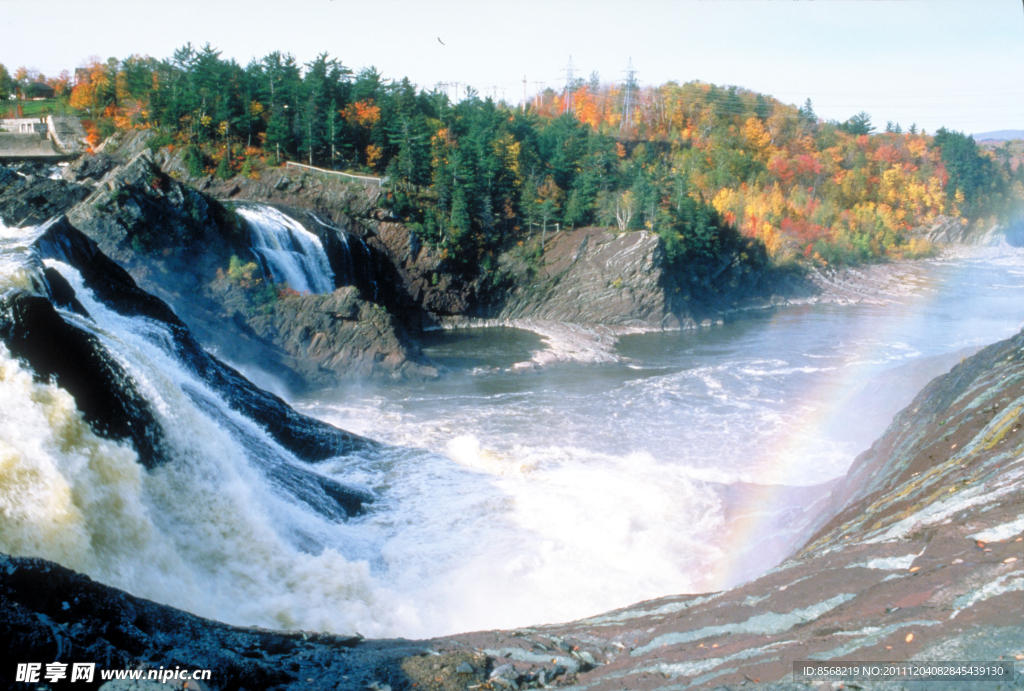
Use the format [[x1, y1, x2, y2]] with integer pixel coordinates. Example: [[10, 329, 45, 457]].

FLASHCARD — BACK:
[[436, 334, 1024, 689]]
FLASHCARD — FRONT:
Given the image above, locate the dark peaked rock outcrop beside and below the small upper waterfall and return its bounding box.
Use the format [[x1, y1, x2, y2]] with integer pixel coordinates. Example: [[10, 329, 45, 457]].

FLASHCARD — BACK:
[[0, 152, 436, 391]]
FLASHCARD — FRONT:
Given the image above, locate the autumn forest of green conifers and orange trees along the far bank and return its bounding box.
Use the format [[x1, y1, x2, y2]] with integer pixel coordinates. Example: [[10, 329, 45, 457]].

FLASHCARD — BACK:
[[0, 44, 1024, 273]]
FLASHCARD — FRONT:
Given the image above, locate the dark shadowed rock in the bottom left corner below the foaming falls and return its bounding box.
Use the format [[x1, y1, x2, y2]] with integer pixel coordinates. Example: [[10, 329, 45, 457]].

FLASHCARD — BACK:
[[0, 555, 422, 691]]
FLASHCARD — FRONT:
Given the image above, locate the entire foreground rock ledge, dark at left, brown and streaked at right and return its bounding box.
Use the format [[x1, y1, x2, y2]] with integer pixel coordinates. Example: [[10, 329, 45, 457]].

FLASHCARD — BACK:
[[0, 323, 1024, 691]]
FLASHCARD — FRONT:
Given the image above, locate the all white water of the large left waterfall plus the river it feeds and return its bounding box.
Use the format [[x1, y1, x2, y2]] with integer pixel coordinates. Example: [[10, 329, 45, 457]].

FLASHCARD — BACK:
[[0, 219, 1024, 637]]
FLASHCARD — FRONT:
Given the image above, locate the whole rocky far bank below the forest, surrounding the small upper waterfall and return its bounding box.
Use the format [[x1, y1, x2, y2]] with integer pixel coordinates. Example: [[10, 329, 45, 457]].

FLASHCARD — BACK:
[[6, 136, 1009, 392]]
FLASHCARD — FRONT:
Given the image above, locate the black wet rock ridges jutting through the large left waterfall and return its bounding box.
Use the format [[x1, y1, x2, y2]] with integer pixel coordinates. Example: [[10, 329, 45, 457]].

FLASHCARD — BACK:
[[0, 217, 376, 518]]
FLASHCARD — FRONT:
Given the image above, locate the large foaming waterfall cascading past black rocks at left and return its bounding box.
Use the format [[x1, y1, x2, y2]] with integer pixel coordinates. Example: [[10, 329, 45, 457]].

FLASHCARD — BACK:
[[0, 227, 400, 634]]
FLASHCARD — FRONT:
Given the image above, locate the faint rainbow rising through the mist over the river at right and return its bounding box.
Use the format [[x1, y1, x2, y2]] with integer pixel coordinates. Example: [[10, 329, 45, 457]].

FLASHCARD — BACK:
[[709, 252, 1024, 590]]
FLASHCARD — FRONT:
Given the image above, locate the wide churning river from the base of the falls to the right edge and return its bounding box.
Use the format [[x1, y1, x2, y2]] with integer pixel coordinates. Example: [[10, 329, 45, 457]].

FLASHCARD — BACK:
[[297, 245, 1024, 634]]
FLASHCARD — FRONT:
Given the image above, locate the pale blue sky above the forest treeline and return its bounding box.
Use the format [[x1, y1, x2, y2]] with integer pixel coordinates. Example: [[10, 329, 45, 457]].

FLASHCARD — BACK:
[[0, 0, 1024, 132]]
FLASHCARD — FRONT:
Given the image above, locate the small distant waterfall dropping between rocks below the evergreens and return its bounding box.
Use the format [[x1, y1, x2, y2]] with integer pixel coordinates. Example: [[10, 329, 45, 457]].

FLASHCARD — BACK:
[[238, 206, 335, 293]]
